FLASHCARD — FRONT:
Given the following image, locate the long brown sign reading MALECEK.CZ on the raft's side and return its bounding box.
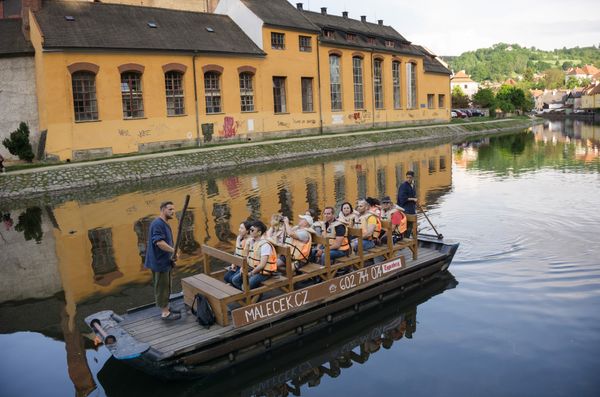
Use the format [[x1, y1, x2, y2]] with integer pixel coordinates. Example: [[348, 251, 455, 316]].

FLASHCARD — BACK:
[[231, 256, 405, 327]]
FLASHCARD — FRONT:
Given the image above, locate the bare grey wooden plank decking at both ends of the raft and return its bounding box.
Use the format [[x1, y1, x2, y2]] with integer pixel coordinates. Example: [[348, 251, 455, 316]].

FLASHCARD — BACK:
[[119, 247, 444, 358]]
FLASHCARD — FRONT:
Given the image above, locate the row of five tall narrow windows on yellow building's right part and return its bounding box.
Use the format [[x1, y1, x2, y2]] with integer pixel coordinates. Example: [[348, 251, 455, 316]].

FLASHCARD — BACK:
[[329, 54, 417, 111]]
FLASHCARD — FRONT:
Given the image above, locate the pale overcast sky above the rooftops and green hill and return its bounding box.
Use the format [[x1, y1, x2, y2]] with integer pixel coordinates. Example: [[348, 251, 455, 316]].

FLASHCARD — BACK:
[[290, 0, 600, 55]]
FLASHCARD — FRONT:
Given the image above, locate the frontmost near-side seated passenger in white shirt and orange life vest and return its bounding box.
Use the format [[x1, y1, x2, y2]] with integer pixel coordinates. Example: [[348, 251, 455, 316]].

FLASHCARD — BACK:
[[231, 221, 277, 289]]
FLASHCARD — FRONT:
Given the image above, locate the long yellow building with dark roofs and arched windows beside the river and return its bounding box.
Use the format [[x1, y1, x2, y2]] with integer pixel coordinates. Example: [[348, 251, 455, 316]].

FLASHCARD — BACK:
[[30, 0, 450, 160]]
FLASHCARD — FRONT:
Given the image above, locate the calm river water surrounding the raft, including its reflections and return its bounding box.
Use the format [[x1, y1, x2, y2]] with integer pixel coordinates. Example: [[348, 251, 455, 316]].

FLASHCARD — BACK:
[[0, 120, 600, 397]]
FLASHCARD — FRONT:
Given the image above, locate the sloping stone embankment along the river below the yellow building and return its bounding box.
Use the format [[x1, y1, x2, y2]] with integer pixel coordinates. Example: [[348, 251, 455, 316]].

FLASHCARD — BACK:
[[0, 119, 535, 199]]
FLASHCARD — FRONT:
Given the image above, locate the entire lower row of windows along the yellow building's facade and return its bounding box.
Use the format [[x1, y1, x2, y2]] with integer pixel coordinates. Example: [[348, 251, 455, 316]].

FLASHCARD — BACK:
[[72, 63, 445, 121]]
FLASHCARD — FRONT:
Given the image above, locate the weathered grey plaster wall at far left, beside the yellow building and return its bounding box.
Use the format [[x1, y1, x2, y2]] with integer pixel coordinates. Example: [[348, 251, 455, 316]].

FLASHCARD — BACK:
[[0, 56, 39, 159]]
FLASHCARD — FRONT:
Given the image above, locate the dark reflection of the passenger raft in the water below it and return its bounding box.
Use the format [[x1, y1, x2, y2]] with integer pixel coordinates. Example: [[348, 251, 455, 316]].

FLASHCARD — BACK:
[[98, 273, 457, 397]]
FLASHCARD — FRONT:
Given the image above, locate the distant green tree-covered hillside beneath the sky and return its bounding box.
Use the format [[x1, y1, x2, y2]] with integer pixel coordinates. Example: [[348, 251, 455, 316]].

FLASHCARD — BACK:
[[443, 43, 600, 82]]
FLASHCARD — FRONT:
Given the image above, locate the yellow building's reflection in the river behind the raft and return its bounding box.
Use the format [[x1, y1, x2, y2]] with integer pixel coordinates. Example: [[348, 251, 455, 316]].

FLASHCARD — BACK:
[[47, 145, 451, 302]]
